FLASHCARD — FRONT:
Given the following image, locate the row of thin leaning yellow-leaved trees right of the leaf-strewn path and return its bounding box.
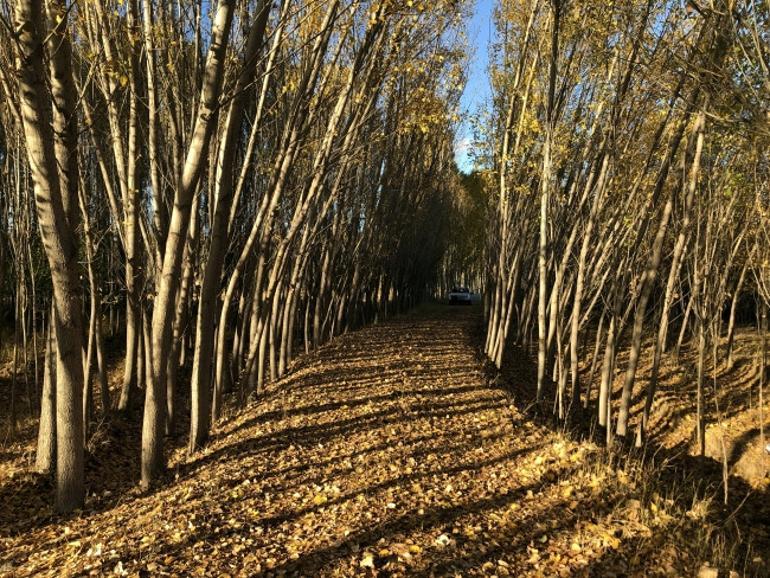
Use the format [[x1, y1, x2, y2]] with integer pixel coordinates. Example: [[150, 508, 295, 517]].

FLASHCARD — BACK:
[[482, 0, 770, 451]]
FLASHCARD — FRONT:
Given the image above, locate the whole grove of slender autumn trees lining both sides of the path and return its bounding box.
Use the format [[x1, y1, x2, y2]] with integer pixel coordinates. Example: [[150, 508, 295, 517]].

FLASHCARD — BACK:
[[0, 0, 770, 512]]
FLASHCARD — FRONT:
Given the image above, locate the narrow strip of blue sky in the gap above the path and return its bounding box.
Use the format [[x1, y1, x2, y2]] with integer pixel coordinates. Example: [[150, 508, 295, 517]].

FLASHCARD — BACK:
[[455, 0, 496, 172]]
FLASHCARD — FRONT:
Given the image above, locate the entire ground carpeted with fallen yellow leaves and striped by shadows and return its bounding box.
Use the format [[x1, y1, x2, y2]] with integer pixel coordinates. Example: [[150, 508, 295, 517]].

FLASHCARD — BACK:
[[0, 306, 770, 576]]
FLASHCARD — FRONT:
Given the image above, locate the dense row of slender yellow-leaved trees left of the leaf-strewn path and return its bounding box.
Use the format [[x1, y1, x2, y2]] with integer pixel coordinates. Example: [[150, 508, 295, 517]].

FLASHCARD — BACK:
[[0, 0, 462, 511]]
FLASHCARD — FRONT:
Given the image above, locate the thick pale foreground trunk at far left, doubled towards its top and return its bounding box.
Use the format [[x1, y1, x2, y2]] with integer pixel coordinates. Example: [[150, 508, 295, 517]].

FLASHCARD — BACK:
[[15, 0, 85, 512]]
